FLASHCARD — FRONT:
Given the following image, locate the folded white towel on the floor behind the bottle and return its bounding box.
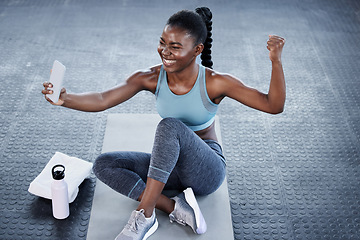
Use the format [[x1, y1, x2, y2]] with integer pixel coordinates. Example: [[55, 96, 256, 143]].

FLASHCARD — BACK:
[[28, 152, 93, 203]]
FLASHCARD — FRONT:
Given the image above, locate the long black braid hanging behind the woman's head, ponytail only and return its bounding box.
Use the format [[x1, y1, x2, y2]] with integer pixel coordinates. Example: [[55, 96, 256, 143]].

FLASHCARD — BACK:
[[195, 7, 213, 68]]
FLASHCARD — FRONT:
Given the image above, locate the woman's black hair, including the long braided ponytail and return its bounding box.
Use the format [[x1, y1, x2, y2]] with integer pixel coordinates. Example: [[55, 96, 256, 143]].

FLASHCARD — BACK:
[[166, 7, 213, 68]]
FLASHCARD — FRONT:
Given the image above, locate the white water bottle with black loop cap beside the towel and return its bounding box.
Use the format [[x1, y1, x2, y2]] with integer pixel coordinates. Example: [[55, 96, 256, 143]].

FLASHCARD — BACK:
[[51, 164, 70, 219]]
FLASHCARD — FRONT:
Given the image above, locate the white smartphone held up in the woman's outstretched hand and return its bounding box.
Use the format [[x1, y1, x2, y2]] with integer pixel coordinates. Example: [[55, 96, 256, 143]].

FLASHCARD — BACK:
[[46, 60, 66, 103]]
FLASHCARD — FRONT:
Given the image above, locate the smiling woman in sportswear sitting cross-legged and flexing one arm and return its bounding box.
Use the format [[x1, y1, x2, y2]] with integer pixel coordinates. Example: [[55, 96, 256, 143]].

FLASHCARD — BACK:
[[42, 7, 285, 240]]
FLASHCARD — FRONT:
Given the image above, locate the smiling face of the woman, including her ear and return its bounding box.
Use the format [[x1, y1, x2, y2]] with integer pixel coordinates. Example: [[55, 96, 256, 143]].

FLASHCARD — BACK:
[[158, 25, 203, 72]]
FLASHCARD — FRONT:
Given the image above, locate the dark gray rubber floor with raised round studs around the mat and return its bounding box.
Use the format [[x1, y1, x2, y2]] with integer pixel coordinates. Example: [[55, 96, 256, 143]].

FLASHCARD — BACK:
[[0, 0, 360, 240]]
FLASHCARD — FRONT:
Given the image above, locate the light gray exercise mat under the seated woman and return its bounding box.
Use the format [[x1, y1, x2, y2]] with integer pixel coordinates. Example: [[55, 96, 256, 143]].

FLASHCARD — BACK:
[[87, 114, 234, 240]]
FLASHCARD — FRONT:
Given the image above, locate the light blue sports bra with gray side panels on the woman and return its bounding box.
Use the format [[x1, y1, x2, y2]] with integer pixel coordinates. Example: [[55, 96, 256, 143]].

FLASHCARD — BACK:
[[155, 65, 218, 131]]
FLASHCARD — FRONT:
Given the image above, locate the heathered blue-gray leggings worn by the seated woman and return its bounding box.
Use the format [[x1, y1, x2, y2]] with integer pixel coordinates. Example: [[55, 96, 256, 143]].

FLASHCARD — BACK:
[[93, 118, 226, 200]]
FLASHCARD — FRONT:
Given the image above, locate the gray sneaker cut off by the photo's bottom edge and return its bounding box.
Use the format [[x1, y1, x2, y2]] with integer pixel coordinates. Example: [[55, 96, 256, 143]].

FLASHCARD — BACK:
[[115, 209, 158, 240]]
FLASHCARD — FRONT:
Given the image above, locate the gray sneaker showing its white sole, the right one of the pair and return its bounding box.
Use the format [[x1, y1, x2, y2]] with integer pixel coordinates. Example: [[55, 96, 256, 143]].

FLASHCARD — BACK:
[[169, 188, 207, 234]]
